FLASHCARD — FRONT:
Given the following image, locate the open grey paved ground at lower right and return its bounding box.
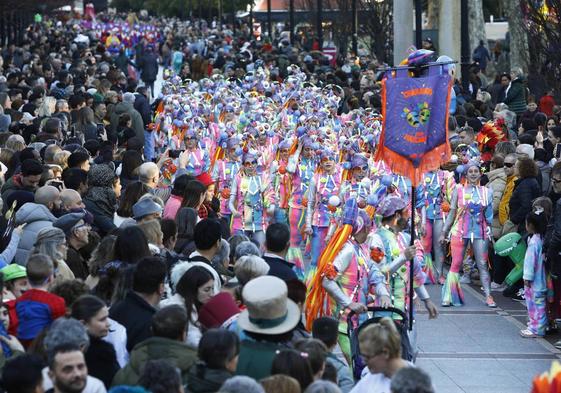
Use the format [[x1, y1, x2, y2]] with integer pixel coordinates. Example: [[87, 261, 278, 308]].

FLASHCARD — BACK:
[[416, 285, 561, 393]]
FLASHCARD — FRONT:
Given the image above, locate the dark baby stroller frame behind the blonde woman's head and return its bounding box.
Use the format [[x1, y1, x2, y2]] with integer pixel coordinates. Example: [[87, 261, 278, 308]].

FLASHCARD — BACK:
[[347, 307, 417, 381]]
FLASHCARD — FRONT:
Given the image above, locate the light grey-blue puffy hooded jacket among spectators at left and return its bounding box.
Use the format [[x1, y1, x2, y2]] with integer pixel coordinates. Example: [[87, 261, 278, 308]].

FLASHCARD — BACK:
[[14, 202, 56, 266]]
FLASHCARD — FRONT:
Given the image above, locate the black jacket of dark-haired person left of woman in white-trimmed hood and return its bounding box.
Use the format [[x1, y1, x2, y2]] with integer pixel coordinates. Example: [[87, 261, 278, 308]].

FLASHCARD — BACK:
[[109, 291, 156, 352]]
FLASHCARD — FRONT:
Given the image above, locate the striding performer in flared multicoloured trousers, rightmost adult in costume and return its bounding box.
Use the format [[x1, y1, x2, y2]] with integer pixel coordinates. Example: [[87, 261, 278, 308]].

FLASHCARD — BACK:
[[440, 161, 497, 307]]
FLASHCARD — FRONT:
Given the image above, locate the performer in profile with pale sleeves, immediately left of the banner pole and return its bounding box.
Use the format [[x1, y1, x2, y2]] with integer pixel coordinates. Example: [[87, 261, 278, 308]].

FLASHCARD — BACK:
[[369, 194, 438, 324]]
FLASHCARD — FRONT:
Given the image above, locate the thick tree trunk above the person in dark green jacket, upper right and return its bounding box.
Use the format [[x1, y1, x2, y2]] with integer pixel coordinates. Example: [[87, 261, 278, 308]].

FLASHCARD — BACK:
[[505, 0, 528, 72]]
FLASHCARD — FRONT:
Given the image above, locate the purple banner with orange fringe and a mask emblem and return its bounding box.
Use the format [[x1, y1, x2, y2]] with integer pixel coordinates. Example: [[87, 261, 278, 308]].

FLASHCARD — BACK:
[[375, 64, 452, 186]]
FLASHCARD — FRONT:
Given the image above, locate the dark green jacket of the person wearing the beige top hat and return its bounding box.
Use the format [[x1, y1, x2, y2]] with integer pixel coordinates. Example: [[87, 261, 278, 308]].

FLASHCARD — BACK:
[[236, 340, 286, 381]]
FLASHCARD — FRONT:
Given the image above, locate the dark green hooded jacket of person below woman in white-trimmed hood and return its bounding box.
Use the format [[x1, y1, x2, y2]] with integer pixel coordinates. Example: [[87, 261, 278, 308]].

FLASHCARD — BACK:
[[111, 337, 197, 386]]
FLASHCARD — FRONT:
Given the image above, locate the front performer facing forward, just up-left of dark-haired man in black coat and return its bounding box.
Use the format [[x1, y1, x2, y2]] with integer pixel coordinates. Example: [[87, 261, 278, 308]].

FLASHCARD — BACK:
[[229, 151, 275, 246]]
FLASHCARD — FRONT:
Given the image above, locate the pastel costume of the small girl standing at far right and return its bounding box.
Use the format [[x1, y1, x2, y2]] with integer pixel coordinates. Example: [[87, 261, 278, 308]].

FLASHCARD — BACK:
[[523, 234, 547, 336]]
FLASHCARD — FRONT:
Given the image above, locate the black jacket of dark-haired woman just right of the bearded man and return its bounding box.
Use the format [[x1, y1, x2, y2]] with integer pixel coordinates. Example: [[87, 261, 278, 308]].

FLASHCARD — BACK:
[[85, 336, 120, 389]]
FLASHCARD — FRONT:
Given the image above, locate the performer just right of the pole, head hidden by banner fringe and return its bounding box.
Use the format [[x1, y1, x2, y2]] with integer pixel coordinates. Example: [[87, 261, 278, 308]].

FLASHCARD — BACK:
[[418, 169, 456, 285]]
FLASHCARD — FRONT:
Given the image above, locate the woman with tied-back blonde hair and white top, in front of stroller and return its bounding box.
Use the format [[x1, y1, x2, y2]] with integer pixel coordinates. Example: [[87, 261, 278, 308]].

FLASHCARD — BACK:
[[350, 317, 412, 393]]
